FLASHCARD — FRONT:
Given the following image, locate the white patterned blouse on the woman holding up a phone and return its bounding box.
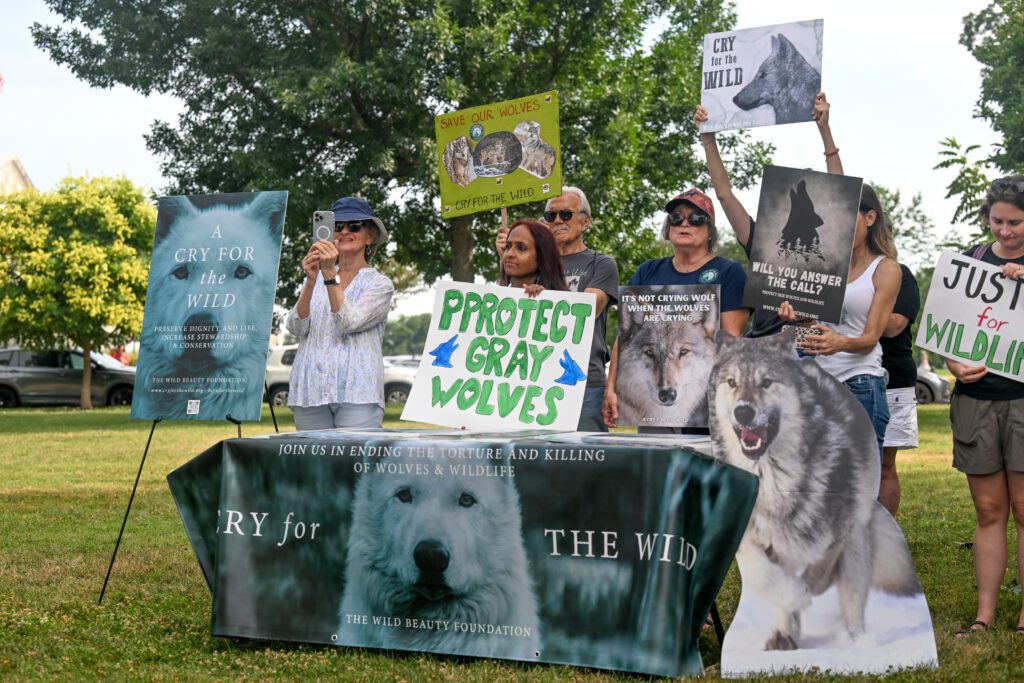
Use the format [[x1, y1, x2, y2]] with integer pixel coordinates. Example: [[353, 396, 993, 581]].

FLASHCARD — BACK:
[[285, 266, 394, 408]]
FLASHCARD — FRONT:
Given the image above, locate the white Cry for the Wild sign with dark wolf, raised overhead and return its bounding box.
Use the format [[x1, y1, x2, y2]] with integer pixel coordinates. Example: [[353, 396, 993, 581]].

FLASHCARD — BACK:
[[700, 19, 824, 133]]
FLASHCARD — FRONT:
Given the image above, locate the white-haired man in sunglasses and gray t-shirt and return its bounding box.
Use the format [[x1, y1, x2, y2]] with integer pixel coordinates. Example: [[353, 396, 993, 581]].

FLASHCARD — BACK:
[[496, 185, 618, 431]]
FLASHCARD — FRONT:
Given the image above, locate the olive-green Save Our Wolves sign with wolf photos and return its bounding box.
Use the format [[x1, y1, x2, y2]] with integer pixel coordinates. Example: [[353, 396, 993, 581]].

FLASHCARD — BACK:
[[434, 90, 562, 218]]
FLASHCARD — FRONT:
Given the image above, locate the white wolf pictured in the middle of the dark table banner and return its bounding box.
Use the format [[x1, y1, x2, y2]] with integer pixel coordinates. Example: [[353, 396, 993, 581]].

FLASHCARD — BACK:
[[337, 460, 541, 660]]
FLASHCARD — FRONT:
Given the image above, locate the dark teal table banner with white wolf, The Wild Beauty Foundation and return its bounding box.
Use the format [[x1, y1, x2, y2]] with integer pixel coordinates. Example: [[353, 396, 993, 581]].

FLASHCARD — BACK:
[[168, 430, 758, 676]]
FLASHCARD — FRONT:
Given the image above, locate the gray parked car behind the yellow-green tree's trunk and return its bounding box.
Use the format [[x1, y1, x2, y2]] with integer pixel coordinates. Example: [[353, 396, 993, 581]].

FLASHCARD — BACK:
[[0, 346, 135, 408]]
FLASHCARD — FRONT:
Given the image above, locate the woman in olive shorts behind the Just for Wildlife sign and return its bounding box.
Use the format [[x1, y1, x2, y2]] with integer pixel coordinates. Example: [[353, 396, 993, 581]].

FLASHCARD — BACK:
[[945, 175, 1024, 638]]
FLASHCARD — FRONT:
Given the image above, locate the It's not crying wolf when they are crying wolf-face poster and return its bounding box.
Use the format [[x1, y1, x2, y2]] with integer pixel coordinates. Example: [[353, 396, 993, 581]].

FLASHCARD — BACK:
[[615, 285, 719, 427]]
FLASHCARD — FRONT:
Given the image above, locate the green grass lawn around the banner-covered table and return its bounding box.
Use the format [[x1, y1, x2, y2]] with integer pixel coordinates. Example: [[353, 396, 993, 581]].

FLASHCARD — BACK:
[[0, 405, 1024, 681]]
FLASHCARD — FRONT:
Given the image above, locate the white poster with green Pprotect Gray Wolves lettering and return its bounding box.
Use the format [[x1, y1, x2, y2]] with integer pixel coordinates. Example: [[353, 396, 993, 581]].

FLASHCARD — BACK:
[[401, 282, 596, 431]]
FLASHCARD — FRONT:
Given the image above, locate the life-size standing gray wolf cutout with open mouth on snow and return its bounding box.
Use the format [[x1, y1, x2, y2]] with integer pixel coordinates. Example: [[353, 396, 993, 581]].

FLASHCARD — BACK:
[[709, 333, 938, 676]]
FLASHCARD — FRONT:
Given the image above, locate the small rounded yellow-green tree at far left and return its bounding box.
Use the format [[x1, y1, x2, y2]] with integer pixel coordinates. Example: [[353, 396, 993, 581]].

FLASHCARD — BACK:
[[0, 177, 157, 409]]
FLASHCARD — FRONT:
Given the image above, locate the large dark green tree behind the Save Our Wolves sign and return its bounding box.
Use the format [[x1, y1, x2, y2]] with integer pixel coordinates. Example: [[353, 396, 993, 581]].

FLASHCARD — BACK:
[[33, 0, 770, 303]]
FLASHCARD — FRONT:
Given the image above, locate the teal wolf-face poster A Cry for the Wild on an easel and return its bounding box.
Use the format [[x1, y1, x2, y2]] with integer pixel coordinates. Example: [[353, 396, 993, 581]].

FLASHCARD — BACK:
[[132, 191, 288, 420]]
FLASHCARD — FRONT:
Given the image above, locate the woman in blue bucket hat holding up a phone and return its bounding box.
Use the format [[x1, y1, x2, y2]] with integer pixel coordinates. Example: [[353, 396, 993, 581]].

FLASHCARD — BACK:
[[286, 197, 394, 431]]
